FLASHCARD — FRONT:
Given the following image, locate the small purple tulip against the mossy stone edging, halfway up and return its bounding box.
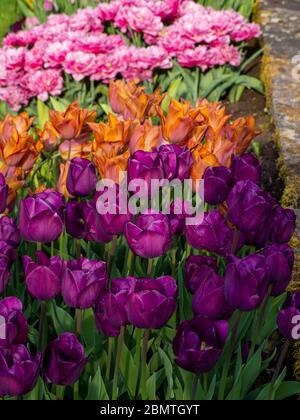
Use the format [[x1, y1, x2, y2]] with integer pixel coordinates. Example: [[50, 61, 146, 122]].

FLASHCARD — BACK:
[[271, 206, 296, 244]]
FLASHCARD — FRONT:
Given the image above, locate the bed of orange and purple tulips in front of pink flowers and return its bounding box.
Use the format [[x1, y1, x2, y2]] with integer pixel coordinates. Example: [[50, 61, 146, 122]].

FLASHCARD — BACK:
[[0, 79, 300, 400]]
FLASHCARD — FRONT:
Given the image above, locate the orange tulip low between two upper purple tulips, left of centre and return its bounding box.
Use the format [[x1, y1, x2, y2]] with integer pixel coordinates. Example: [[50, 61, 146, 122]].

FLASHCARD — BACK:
[[94, 149, 130, 184]]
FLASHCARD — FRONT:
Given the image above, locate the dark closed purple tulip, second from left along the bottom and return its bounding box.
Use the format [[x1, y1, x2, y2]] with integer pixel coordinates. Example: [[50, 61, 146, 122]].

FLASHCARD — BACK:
[[43, 333, 88, 385]]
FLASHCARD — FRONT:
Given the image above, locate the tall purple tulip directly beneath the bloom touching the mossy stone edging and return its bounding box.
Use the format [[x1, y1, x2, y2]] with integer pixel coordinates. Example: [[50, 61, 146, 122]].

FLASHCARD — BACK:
[[263, 244, 294, 296]]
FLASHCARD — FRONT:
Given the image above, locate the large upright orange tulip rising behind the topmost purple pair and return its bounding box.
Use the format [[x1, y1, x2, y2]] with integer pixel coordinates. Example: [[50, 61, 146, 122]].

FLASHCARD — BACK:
[[157, 99, 201, 145]]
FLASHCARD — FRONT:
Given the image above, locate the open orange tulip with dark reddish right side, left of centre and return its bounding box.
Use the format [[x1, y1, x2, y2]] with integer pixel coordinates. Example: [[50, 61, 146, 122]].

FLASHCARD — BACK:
[[49, 101, 96, 141]]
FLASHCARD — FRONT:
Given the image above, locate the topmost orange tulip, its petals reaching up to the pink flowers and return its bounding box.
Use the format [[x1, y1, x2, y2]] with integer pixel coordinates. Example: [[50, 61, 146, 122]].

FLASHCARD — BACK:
[[108, 80, 164, 121]]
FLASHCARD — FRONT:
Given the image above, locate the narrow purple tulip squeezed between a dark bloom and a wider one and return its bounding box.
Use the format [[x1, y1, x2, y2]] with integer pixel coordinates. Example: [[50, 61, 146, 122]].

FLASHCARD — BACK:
[[83, 201, 113, 244]]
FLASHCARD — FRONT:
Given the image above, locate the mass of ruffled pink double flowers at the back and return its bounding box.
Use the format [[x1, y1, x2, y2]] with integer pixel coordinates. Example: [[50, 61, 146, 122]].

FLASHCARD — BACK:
[[0, 0, 260, 110]]
